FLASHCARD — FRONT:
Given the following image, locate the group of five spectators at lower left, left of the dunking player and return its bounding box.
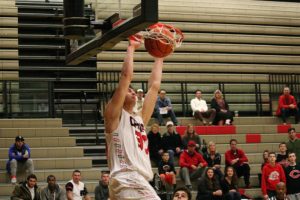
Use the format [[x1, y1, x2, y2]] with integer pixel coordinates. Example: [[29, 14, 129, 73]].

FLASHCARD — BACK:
[[7, 136, 109, 200]]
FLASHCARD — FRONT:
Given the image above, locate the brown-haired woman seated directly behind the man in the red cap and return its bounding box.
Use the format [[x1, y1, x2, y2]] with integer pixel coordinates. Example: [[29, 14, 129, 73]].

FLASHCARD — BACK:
[[182, 124, 202, 153]]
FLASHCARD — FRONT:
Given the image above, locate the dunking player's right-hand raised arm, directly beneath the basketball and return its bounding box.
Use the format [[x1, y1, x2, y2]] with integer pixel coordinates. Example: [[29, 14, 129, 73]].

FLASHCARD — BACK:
[[142, 58, 164, 126]]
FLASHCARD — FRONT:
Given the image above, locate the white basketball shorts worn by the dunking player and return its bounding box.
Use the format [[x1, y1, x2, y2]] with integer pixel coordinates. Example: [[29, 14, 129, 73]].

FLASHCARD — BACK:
[[109, 171, 160, 200]]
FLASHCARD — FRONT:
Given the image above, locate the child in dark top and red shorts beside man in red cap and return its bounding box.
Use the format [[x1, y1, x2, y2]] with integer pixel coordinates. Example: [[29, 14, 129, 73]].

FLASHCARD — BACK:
[[158, 152, 176, 190]]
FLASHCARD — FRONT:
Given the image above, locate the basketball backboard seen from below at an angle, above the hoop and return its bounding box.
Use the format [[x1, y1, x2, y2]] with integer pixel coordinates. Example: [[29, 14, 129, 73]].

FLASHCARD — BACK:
[[64, 0, 158, 65]]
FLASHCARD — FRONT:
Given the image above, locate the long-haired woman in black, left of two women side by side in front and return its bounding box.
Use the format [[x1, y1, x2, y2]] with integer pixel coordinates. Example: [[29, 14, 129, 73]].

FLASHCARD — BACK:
[[196, 167, 223, 200]]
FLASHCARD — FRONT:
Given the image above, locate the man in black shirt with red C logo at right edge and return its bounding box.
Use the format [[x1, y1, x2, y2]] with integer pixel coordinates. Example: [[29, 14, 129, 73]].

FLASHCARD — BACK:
[[284, 152, 300, 199]]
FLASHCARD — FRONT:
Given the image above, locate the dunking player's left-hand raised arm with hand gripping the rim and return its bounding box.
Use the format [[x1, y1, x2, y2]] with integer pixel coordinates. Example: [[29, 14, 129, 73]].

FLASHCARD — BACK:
[[104, 41, 140, 133]]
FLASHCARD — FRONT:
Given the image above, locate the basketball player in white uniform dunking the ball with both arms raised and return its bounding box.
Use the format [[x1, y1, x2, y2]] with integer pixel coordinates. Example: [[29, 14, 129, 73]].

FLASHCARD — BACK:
[[104, 37, 163, 200]]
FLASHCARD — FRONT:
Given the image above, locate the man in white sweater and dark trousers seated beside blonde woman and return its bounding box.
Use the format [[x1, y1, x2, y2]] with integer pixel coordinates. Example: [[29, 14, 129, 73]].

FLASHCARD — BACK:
[[191, 90, 216, 125]]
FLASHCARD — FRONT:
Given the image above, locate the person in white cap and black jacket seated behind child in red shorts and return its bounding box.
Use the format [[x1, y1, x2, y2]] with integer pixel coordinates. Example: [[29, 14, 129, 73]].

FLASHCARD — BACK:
[[162, 121, 182, 163]]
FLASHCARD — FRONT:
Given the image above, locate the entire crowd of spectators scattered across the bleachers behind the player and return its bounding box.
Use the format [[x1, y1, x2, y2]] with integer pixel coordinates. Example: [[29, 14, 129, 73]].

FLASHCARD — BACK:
[[7, 87, 300, 200]]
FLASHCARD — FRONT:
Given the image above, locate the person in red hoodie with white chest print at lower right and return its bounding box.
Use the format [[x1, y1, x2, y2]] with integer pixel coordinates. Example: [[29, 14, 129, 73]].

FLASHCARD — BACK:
[[261, 152, 286, 200]]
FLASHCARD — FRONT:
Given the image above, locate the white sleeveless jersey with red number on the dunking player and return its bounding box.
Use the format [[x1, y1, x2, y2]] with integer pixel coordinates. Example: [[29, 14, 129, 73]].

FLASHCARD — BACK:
[[106, 109, 153, 181]]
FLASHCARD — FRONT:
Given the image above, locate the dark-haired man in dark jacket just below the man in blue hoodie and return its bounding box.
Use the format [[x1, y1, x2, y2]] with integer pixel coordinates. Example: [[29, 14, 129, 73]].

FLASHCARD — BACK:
[[10, 174, 40, 200]]
